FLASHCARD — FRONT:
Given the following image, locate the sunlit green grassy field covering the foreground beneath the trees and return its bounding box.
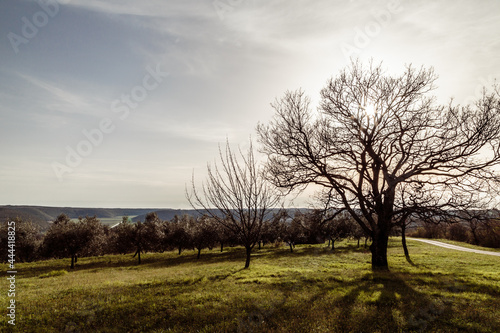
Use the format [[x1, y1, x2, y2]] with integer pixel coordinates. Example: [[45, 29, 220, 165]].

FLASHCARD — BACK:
[[0, 238, 500, 332]]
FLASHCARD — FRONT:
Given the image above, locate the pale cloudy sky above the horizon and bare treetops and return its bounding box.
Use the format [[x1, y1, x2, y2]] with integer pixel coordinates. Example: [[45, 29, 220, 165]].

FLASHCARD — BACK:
[[0, 0, 500, 208]]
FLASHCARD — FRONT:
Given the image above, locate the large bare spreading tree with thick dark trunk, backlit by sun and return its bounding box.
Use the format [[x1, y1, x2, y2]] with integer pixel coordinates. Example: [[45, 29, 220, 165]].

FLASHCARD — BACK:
[[257, 61, 500, 269]]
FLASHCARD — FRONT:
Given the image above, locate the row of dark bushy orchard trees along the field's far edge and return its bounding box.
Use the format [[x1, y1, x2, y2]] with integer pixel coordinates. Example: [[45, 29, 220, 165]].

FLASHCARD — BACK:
[[0, 209, 500, 268]]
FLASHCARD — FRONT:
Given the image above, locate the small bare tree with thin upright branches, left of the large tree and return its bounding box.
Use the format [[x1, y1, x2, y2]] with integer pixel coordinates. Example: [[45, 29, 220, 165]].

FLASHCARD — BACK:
[[186, 142, 281, 268]]
